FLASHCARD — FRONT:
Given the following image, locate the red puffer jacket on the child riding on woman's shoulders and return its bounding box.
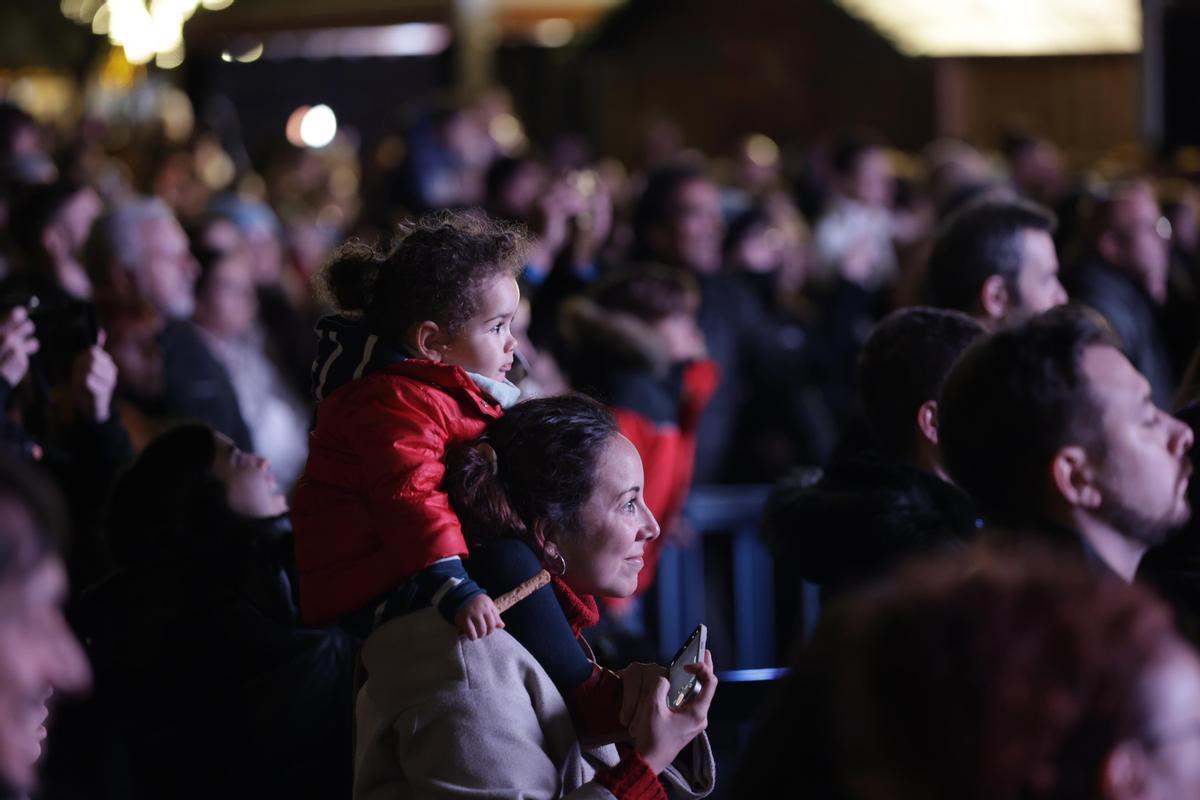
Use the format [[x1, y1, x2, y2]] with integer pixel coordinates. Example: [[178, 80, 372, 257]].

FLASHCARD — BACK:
[[292, 359, 504, 625]]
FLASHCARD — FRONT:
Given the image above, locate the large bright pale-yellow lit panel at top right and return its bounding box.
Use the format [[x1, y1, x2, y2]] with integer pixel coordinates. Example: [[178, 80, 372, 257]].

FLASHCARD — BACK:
[[835, 0, 1141, 56]]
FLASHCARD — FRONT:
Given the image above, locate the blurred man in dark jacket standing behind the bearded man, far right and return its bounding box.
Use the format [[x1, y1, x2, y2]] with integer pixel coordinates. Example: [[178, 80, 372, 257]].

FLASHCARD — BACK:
[[1067, 180, 1176, 408]]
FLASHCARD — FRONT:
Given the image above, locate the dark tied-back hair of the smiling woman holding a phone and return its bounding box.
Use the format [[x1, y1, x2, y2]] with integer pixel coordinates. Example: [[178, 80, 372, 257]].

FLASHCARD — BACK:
[[445, 395, 618, 552]]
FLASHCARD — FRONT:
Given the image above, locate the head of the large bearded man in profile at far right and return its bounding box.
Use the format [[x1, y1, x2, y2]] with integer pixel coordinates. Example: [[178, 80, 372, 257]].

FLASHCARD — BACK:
[[940, 306, 1193, 581]]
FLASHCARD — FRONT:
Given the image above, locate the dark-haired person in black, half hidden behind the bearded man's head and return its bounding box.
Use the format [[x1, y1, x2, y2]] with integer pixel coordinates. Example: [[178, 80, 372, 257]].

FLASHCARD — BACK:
[[768, 308, 984, 601]]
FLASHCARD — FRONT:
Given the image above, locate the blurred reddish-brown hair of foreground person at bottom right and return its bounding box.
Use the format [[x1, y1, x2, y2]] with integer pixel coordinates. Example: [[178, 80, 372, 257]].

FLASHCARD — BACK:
[[739, 549, 1183, 800]]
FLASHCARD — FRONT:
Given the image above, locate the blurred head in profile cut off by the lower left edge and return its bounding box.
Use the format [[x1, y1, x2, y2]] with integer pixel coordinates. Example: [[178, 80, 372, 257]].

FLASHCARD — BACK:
[[0, 459, 91, 798]]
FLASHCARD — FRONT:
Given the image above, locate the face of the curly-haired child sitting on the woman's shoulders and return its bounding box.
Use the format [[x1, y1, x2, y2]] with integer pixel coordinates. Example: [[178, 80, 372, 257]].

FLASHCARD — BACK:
[[442, 275, 521, 380]]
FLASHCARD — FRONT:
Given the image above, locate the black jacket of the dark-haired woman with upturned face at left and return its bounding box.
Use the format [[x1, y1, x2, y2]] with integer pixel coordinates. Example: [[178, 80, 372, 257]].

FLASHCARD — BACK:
[[47, 523, 354, 800]]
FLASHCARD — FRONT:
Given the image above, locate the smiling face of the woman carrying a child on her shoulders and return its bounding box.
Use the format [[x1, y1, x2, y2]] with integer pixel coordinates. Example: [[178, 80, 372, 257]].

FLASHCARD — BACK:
[[557, 434, 659, 597]]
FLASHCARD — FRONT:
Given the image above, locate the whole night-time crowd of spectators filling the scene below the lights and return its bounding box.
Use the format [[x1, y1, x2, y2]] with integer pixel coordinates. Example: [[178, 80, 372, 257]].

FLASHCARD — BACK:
[[0, 82, 1200, 800]]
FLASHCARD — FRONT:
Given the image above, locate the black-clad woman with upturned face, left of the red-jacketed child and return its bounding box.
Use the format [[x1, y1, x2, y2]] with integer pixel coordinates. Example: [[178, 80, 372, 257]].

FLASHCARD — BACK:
[[52, 425, 353, 799]]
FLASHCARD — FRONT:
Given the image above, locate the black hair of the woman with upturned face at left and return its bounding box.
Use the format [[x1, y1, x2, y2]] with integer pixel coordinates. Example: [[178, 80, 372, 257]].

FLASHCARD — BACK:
[[108, 423, 240, 564]]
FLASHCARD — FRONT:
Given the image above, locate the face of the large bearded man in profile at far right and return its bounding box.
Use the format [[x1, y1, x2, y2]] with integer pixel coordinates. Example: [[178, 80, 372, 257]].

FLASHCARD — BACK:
[[1080, 345, 1192, 546]]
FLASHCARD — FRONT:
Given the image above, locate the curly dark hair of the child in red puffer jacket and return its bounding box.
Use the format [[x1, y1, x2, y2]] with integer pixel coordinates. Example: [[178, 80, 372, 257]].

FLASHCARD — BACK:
[[320, 211, 528, 345]]
